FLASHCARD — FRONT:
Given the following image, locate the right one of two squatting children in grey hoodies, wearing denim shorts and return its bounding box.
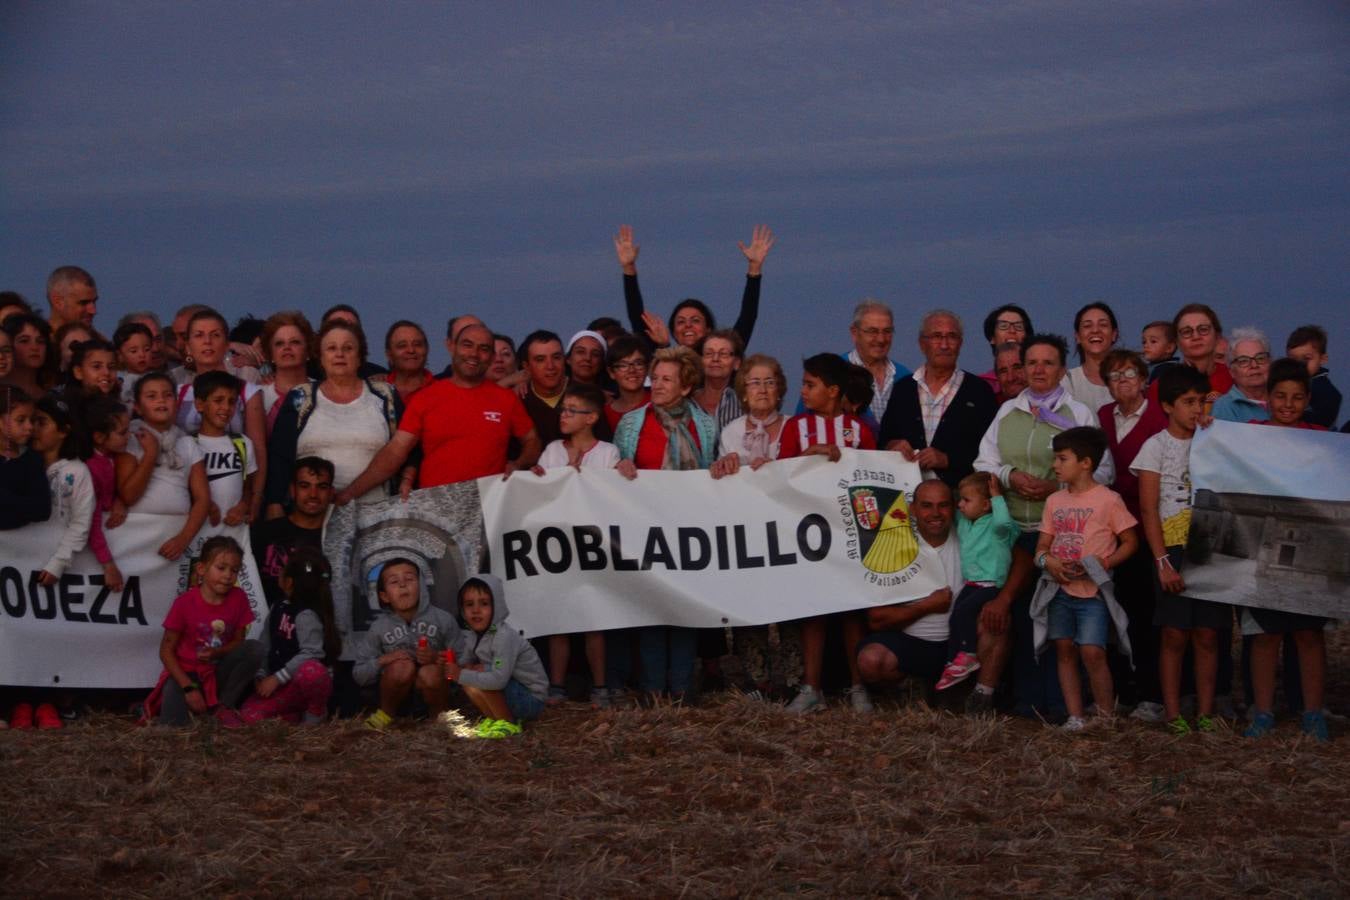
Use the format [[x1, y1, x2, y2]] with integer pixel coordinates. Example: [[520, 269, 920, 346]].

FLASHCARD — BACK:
[[446, 575, 548, 738]]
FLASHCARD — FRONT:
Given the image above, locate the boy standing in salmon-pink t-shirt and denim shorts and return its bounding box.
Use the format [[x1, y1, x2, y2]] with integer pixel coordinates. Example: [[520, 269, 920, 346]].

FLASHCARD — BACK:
[[1031, 426, 1139, 731]]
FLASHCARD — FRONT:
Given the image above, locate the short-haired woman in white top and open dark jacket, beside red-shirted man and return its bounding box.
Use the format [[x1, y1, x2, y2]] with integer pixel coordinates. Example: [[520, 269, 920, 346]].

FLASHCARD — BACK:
[[266, 318, 404, 518]]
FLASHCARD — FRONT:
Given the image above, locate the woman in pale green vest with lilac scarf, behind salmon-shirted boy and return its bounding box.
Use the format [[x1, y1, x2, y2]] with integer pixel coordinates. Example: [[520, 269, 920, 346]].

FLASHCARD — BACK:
[[975, 335, 1115, 714]]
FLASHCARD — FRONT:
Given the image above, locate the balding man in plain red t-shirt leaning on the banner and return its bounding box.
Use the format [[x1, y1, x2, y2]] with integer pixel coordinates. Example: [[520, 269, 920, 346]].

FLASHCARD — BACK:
[[333, 324, 543, 506]]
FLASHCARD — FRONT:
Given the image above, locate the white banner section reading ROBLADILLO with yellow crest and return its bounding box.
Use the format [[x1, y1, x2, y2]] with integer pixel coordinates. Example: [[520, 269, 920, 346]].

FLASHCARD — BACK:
[[478, 451, 945, 637]]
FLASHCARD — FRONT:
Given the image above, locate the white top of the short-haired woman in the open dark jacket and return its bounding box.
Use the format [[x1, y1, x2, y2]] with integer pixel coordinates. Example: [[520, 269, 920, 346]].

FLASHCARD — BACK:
[[296, 385, 389, 503]]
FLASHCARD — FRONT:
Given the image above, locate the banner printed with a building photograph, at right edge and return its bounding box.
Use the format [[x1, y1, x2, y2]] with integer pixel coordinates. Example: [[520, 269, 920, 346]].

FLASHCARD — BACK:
[[1181, 422, 1350, 619]]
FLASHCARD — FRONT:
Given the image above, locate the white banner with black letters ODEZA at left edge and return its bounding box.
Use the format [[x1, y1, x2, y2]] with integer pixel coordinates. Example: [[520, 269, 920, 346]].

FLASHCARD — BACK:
[[0, 513, 267, 688]]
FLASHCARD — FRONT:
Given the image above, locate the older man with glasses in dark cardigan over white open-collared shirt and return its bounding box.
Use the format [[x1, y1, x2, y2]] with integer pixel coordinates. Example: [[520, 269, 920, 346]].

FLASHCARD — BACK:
[[878, 309, 999, 490]]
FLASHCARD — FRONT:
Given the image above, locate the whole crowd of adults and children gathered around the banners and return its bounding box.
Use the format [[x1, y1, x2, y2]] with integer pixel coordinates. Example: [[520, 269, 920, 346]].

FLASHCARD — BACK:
[[0, 236, 1341, 739]]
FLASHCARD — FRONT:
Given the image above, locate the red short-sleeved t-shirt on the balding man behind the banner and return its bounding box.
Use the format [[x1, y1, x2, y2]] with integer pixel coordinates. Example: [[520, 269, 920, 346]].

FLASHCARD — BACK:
[[398, 379, 535, 487]]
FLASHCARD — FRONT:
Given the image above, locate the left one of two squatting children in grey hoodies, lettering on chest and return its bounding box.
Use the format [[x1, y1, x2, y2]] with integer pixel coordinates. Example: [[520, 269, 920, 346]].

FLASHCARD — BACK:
[[352, 557, 459, 731]]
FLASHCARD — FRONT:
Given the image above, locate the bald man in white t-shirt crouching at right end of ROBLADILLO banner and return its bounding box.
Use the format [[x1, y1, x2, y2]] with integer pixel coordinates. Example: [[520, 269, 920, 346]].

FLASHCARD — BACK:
[[857, 483, 966, 685]]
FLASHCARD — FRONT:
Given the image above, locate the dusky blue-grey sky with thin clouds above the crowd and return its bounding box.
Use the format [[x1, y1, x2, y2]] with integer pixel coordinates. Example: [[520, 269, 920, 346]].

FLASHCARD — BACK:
[[0, 0, 1350, 382]]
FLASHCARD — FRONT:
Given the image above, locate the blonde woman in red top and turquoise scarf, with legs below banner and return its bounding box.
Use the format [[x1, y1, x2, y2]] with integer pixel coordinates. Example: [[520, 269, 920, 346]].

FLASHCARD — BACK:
[[608, 347, 717, 700]]
